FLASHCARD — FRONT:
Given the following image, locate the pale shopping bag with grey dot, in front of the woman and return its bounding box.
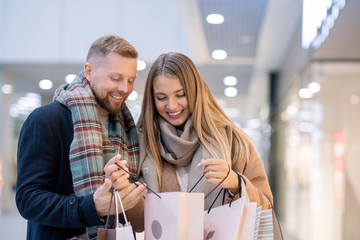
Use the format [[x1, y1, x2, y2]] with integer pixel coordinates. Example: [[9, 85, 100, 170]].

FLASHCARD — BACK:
[[144, 192, 204, 240]]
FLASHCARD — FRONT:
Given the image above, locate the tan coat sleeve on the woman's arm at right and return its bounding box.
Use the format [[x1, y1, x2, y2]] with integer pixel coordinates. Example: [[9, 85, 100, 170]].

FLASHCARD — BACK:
[[232, 135, 273, 209]]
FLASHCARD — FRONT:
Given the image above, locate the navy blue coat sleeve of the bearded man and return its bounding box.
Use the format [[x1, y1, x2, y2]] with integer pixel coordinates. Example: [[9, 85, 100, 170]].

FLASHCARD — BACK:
[[16, 105, 102, 228]]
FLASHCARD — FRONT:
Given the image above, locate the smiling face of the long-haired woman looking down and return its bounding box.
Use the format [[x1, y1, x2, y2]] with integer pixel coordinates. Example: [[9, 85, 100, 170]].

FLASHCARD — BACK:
[[153, 75, 190, 127]]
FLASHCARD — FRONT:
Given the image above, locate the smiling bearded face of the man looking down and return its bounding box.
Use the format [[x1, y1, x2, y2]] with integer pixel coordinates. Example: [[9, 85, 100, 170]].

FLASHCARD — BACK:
[[84, 52, 137, 116]]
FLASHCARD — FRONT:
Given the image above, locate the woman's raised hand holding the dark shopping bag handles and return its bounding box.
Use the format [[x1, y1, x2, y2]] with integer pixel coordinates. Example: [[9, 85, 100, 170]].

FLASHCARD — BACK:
[[198, 158, 239, 192]]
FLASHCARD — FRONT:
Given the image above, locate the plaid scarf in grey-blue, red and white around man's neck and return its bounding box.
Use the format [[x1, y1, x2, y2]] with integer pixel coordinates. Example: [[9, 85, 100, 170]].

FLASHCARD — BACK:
[[53, 72, 139, 239]]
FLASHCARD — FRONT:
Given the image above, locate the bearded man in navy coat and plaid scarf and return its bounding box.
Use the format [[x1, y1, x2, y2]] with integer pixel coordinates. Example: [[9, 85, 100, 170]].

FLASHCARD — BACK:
[[16, 35, 146, 240]]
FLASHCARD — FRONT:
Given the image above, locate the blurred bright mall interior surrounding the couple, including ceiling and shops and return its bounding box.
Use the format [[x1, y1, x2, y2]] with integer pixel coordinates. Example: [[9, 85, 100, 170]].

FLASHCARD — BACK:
[[0, 0, 360, 240]]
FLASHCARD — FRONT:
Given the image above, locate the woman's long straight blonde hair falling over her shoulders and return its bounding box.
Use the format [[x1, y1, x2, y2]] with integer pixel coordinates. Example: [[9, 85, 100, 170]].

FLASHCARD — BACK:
[[137, 52, 250, 183]]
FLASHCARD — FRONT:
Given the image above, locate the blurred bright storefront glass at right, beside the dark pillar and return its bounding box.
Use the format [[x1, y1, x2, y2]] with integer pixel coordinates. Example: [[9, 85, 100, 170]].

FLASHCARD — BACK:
[[273, 61, 360, 240]]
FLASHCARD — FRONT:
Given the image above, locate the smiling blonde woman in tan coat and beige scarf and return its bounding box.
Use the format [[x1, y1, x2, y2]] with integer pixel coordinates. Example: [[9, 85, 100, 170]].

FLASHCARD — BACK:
[[137, 53, 273, 209]]
